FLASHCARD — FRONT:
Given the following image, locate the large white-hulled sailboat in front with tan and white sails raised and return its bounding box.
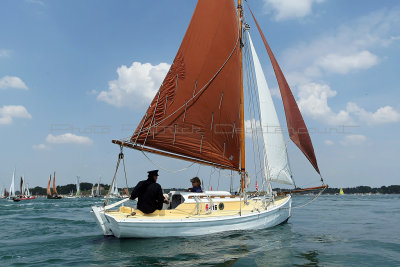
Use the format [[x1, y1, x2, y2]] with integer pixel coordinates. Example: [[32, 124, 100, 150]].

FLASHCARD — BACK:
[[92, 0, 327, 238]]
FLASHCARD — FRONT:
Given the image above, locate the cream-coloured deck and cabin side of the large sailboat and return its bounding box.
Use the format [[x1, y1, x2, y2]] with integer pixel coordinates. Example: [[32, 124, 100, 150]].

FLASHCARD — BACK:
[[106, 196, 288, 220]]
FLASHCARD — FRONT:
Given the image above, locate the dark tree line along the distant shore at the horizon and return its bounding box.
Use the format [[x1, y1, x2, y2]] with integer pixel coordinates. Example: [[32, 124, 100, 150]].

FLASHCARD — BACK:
[[30, 183, 400, 195]]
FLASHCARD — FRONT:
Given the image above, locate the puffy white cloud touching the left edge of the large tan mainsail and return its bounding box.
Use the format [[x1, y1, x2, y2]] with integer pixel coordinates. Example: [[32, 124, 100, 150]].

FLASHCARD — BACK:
[[97, 62, 170, 108]]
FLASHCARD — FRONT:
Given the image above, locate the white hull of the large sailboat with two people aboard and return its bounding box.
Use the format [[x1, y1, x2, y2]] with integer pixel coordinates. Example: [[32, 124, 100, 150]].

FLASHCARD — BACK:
[[92, 197, 292, 238]]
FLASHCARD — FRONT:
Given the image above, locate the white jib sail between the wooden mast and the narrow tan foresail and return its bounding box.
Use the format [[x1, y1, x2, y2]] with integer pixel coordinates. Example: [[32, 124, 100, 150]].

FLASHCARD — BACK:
[[247, 32, 294, 185]]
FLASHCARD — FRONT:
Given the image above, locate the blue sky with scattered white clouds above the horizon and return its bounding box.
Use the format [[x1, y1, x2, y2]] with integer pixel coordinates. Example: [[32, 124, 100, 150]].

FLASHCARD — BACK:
[[0, 0, 400, 190]]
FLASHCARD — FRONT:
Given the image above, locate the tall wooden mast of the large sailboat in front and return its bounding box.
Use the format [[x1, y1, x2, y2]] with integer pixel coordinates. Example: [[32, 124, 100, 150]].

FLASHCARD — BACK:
[[237, 0, 246, 192]]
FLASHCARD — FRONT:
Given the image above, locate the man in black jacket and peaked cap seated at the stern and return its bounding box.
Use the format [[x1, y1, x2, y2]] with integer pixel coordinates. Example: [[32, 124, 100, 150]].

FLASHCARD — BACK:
[[130, 170, 168, 214]]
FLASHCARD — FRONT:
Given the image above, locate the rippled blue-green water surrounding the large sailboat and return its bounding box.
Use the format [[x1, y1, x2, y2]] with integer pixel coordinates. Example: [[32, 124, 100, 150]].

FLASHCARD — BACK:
[[0, 195, 400, 266]]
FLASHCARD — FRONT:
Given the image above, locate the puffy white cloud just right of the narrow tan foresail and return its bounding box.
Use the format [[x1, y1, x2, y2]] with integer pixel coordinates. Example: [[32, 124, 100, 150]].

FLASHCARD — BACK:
[[297, 83, 353, 125]]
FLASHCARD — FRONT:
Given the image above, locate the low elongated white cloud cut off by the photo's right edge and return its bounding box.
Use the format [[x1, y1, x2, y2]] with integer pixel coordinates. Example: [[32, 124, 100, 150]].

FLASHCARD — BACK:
[[347, 102, 400, 125]]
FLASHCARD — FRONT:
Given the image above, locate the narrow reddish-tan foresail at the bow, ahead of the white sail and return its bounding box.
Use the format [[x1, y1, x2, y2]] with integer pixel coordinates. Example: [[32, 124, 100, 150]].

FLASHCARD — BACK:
[[249, 7, 320, 176]]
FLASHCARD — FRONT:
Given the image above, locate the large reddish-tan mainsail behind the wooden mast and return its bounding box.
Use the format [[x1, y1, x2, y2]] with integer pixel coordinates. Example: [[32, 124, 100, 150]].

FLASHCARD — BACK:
[[130, 0, 241, 170]]
